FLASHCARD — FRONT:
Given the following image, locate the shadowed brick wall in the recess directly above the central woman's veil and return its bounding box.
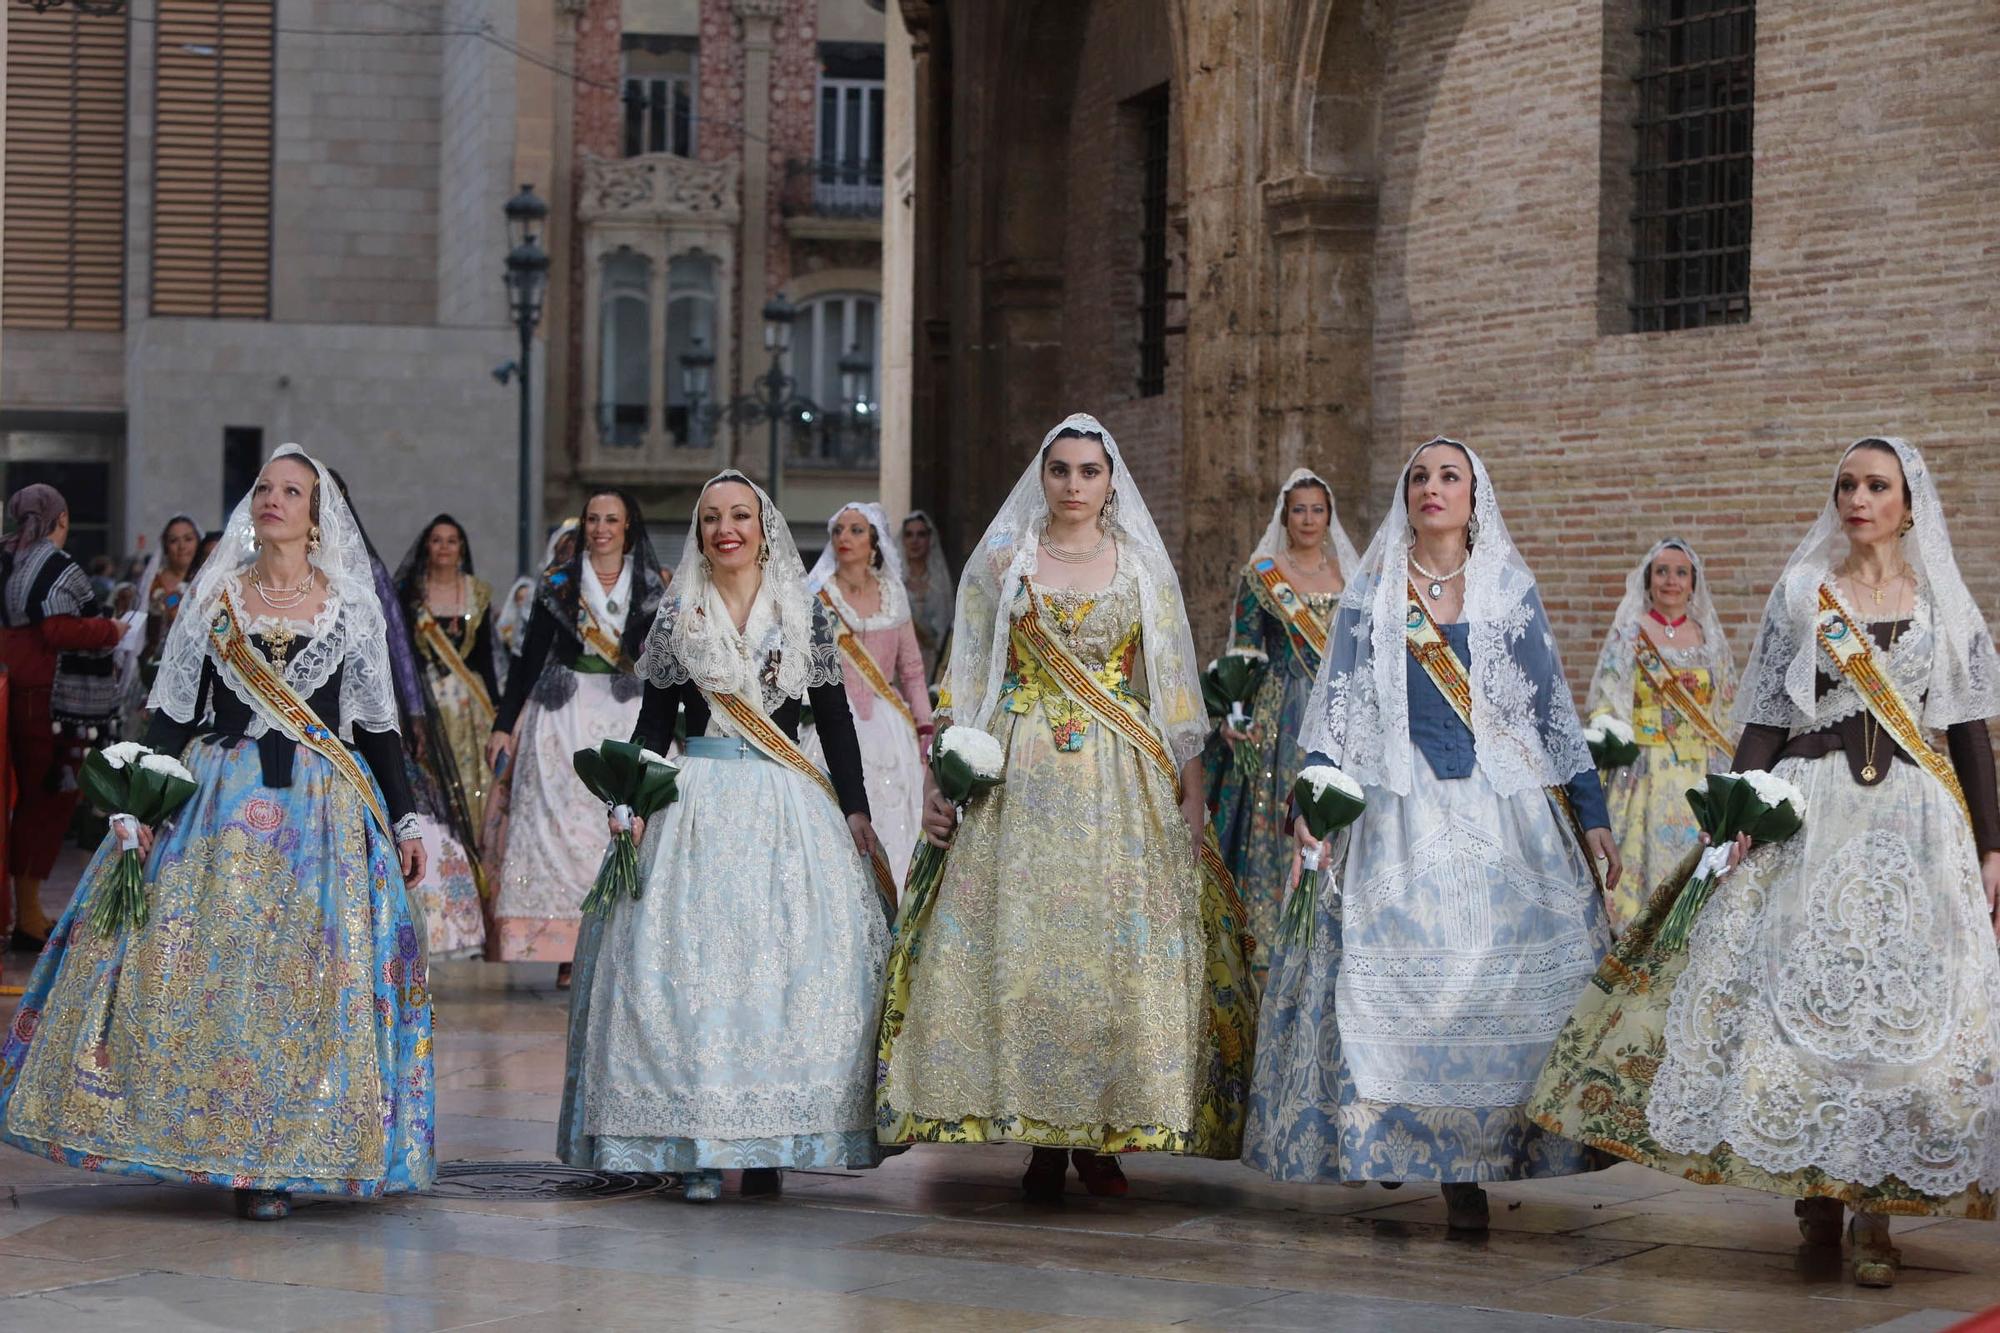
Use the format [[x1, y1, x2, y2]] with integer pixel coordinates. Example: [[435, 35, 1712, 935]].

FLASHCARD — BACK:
[[1056, 0, 1184, 550]]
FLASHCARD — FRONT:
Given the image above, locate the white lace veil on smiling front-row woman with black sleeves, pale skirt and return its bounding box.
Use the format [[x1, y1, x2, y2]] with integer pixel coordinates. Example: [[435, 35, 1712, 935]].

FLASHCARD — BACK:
[[638, 470, 840, 713]]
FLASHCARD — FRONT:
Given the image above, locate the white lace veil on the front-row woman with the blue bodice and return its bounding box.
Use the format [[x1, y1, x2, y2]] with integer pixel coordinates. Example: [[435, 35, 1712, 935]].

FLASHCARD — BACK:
[[1300, 436, 1592, 797]]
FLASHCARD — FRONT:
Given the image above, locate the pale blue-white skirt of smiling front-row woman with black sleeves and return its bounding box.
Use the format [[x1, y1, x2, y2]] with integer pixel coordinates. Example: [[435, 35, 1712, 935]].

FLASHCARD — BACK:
[[558, 737, 888, 1171]]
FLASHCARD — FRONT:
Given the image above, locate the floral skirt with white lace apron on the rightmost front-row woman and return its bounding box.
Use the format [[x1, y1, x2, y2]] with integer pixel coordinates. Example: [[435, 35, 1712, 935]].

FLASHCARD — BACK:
[[1528, 753, 2000, 1219]]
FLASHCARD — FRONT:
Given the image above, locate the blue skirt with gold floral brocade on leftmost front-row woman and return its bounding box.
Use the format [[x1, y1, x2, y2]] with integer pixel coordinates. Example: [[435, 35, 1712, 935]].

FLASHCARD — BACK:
[[0, 741, 434, 1197]]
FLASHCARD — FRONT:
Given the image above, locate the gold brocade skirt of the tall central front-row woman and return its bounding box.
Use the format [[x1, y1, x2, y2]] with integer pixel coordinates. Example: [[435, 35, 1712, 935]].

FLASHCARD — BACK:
[[876, 705, 1256, 1159]]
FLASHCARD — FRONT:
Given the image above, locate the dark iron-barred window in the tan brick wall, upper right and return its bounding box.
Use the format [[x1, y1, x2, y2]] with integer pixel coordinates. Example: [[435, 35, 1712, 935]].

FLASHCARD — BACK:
[[1632, 0, 1756, 332]]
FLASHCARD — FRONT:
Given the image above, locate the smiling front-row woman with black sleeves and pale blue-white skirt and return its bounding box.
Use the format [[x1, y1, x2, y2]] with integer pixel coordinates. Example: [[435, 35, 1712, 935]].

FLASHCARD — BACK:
[[558, 472, 888, 1201]]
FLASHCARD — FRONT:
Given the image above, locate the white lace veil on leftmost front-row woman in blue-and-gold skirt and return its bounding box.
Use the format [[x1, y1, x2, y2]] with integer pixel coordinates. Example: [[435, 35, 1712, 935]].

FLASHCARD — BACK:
[[146, 444, 400, 741]]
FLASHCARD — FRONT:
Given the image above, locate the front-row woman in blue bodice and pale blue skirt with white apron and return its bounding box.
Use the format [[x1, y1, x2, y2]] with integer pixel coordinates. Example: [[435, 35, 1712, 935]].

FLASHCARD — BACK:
[[1244, 438, 1620, 1229]]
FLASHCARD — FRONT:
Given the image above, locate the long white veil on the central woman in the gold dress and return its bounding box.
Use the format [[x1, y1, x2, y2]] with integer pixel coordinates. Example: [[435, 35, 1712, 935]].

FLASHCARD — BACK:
[[940, 412, 1208, 765]]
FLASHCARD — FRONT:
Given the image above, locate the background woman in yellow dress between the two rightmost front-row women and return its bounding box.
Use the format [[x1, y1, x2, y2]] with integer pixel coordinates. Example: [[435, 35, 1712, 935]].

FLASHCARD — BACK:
[[1584, 536, 1736, 931]]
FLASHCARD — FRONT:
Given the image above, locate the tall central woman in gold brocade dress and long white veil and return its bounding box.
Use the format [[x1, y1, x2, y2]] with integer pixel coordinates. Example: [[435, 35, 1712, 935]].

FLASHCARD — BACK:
[[876, 414, 1254, 1199]]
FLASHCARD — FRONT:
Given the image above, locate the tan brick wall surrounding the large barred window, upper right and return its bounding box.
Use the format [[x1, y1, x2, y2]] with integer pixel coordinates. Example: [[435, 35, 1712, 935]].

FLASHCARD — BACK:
[[1376, 0, 2000, 693]]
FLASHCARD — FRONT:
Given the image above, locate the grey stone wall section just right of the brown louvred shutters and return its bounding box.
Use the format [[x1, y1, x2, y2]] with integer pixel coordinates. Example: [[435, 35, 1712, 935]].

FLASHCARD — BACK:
[[272, 0, 444, 324]]
